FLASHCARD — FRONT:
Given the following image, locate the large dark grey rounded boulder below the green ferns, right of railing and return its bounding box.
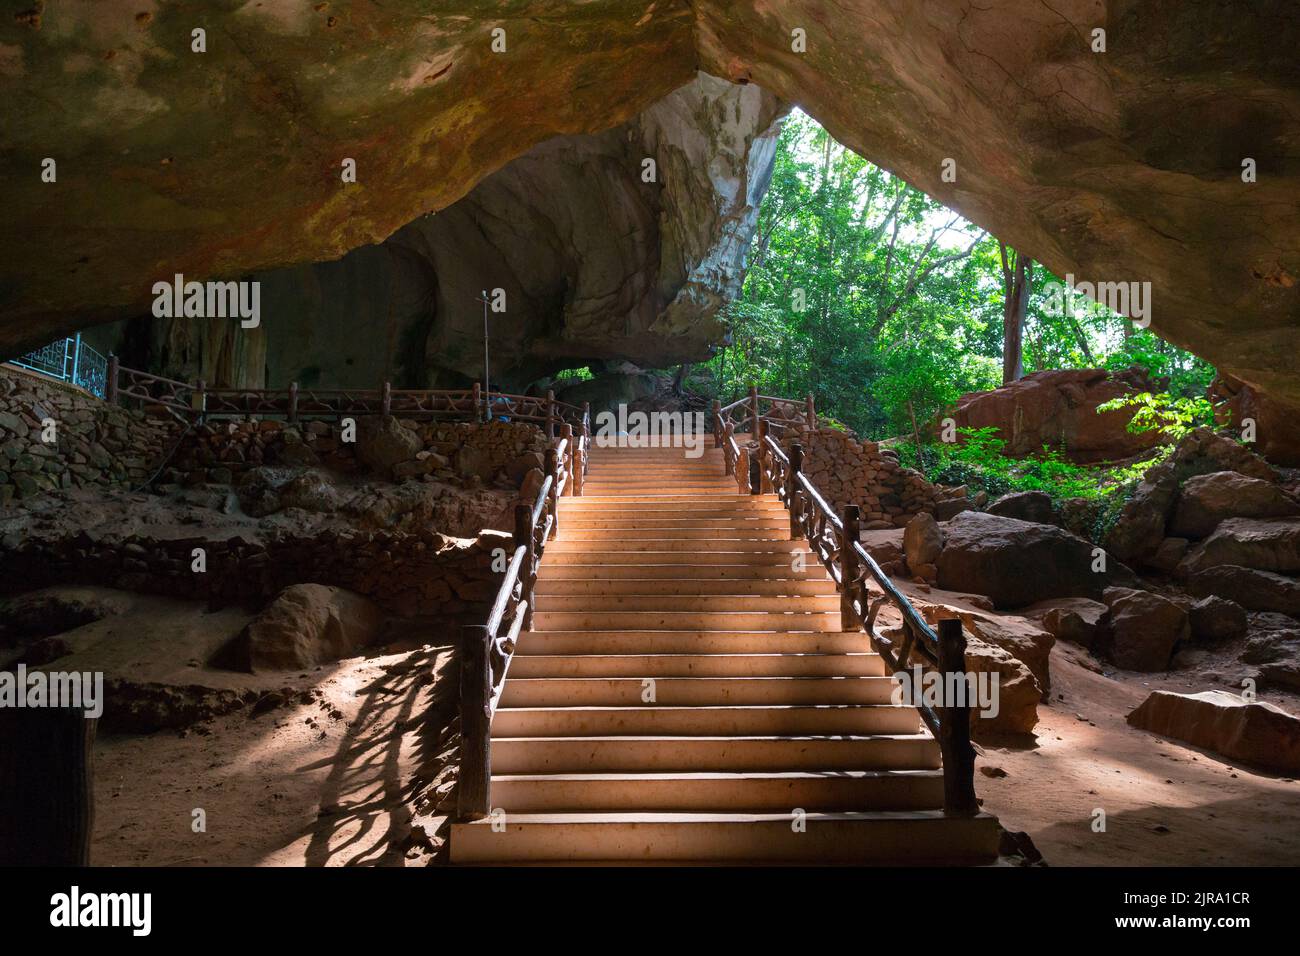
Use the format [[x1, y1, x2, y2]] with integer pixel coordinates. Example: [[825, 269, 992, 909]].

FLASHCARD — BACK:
[[939, 511, 1132, 609]]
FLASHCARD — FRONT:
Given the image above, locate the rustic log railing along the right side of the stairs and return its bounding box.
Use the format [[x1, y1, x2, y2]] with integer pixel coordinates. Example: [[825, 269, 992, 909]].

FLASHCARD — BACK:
[[714, 389, 979, 816]]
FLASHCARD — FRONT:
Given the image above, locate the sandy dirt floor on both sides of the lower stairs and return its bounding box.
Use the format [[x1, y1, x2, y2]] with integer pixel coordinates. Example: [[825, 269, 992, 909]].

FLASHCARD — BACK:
[[83, 632, 1300, 866]]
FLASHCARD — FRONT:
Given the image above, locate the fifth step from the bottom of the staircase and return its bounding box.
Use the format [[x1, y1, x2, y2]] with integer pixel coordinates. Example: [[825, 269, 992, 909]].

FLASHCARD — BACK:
[[501, 674, 894, 708]]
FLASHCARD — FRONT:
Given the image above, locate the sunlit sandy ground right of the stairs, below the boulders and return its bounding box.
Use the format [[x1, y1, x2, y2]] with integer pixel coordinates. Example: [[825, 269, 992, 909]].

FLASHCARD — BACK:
[[975, 645, 1300, 866]]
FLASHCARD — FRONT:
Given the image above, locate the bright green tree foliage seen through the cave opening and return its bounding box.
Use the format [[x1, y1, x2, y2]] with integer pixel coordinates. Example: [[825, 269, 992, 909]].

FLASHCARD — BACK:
[[709, 111, 1214, 442]]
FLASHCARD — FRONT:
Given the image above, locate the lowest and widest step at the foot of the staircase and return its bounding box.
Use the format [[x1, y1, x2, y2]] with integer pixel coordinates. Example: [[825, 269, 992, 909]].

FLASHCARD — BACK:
[[451, 810, 1000, 865]]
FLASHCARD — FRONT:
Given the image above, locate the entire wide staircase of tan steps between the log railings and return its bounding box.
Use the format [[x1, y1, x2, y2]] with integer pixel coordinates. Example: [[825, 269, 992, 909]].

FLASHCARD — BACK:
[[451, 449, 998, 864]]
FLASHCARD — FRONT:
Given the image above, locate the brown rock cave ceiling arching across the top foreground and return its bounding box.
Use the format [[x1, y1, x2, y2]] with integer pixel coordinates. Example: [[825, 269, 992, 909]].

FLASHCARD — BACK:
[[0, 6, 1300, 411]]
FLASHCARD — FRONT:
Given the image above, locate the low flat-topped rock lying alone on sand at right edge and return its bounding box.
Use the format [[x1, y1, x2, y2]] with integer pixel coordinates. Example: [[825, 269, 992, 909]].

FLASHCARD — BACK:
[[1128, 691, 1300, 774]]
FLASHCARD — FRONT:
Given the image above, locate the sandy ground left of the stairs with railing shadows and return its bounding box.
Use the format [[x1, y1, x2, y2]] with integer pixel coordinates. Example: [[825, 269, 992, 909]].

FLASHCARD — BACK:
[[91, 648, 455, 866]]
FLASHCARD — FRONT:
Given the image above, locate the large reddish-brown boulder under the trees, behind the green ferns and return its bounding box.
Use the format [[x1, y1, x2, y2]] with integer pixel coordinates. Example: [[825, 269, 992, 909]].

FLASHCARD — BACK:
[[949, 368, 1162, 465]]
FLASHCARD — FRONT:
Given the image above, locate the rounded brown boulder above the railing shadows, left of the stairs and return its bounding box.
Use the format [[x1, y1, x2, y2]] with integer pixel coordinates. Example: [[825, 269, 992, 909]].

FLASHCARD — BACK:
[[234, 584, 384, 674]]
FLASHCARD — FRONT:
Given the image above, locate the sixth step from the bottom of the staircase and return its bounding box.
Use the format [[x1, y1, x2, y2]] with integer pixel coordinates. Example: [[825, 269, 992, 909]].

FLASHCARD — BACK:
[[510, 649, 885, 680]]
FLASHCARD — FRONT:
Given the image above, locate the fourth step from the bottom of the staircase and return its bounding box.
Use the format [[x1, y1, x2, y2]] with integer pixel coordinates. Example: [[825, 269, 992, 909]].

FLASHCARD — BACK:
[[491, 704, 920, 738]]
